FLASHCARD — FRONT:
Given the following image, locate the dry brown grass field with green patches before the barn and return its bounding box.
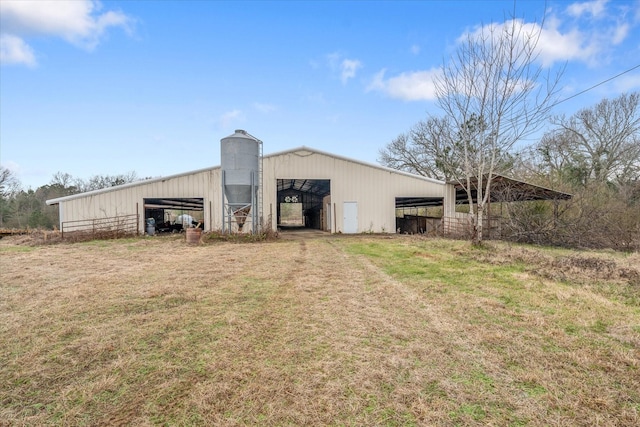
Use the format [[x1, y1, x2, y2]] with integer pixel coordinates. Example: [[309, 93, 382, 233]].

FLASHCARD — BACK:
[[0, 235, 640, 426]]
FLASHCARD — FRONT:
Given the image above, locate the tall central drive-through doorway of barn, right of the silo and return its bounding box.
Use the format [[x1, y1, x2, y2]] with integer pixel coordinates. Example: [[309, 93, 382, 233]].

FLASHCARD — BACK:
[[277, 178, 333, 231]]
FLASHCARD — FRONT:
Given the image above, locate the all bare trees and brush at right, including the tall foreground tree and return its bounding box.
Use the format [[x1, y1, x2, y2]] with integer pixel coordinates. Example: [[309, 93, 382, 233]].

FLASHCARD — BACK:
[[378, 15, 640, 249]]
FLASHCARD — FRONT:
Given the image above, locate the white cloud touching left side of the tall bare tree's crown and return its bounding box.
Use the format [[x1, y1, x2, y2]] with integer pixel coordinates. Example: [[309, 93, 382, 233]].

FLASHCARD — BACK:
[[367, 68, 440, 101]]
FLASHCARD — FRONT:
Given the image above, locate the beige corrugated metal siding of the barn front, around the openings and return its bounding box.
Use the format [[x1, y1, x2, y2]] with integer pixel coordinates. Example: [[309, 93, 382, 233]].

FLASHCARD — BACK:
[[58, 149, 446, 233]]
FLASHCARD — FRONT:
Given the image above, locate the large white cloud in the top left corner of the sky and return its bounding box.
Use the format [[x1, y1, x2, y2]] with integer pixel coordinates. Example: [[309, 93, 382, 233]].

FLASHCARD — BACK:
[[0, 0, 133, 64]]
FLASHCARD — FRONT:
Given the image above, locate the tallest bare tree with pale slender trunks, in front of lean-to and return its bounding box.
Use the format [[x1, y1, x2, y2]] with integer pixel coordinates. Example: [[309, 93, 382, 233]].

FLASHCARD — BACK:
[[435, 19, 562, 243]]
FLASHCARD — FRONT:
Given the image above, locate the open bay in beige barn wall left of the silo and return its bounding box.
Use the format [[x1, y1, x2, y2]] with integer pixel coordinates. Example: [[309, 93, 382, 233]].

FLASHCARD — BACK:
[[144, 197, 204, 233]]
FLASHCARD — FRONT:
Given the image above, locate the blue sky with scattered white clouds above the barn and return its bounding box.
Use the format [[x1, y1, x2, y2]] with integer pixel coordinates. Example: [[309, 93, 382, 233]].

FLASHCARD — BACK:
[[0, 0, 640, 189]]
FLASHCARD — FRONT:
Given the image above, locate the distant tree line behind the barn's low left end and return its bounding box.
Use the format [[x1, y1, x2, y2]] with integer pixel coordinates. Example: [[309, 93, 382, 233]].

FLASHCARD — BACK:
[[0, 171, 139, 229]]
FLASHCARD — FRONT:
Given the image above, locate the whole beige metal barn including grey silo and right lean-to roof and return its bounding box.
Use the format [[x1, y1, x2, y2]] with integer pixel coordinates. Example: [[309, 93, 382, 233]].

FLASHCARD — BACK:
[[47, 130, 571, 235]]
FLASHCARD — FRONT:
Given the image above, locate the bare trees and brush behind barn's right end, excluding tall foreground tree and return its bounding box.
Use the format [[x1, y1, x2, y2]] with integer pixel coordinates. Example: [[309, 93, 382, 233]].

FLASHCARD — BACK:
[[379, 92, 640, 250]]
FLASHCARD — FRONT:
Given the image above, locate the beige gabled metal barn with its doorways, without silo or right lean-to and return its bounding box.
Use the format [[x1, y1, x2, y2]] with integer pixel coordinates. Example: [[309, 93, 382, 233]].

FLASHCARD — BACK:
[[47, 131, 455, 237]]
